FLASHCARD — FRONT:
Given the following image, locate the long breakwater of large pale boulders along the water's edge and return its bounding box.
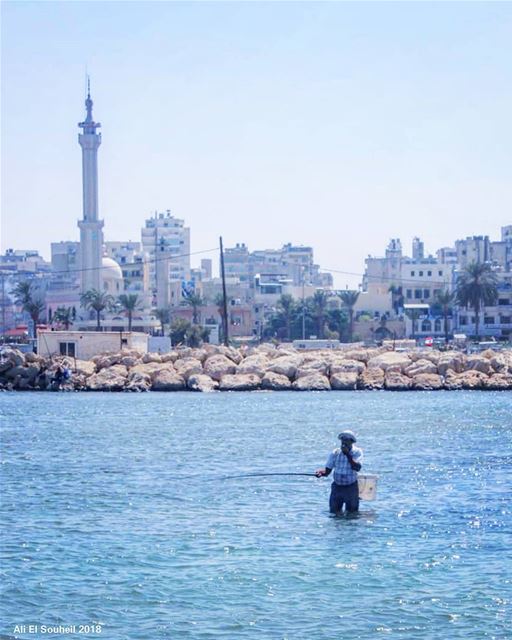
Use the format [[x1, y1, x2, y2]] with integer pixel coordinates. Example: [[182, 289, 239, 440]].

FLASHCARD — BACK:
[[0, 344, 512, 392]]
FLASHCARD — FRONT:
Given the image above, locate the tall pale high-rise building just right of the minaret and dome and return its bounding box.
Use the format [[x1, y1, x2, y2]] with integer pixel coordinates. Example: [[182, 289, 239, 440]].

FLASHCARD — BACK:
[[142, 210, 190, 308]]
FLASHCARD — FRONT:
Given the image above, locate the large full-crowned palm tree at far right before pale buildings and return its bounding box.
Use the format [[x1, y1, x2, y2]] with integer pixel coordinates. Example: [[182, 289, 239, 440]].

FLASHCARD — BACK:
[[456, 262, 498, 340]]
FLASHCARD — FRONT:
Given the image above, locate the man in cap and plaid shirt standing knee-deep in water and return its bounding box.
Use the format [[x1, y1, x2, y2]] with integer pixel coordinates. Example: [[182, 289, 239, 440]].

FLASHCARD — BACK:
[[315, 430, 363, 515]]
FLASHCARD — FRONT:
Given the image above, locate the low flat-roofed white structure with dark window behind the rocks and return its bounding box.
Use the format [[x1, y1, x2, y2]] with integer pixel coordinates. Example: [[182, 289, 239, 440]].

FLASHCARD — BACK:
[[37, 331, 149, 360]]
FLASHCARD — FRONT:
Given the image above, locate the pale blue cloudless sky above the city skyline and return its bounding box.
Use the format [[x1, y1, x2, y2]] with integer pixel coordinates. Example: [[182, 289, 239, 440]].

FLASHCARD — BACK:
[[1, 1, 512, 288]]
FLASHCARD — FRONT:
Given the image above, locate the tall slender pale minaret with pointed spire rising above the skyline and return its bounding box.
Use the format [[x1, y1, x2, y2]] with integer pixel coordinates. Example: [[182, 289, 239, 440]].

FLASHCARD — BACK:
[[78, 81, 103, 293]]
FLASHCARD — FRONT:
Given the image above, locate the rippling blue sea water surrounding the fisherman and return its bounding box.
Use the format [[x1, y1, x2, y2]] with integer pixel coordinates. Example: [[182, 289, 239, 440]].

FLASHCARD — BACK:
[[0, 392, 512, 640]]
